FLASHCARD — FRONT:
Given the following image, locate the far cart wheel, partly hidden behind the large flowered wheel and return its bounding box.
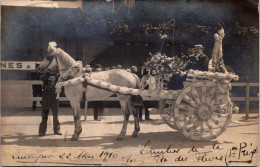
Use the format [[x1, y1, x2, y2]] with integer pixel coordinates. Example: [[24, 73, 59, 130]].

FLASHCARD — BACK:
[[159, 100, 178, 130]]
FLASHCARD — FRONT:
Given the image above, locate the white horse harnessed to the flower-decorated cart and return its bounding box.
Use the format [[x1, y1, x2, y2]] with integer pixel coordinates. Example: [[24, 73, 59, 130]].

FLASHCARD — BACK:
[[38, 42, 141, 140]]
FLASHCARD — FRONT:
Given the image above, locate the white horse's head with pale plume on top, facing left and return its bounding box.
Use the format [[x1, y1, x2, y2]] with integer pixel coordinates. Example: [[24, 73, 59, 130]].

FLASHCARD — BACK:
[[36, 42, 58, 72]]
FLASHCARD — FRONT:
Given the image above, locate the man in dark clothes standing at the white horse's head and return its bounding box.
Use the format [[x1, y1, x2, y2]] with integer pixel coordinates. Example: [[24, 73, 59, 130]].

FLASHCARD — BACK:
[[39, 72, 62, 136]]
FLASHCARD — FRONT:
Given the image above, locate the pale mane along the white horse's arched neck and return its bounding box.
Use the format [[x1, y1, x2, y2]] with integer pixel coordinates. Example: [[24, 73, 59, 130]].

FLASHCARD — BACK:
[[55, 48, 77, 69]]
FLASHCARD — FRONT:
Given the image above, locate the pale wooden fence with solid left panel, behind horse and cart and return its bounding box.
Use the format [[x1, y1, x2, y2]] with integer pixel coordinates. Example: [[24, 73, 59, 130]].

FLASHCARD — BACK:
[[1, 80, 259, 119]]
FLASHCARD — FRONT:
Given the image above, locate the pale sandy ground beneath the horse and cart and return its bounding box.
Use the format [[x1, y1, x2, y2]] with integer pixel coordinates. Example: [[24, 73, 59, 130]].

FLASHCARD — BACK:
[[1, 108, 259, 166]]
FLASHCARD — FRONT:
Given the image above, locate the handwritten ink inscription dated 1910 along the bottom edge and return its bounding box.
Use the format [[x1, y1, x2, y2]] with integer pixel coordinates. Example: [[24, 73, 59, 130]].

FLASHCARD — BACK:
[[11, 140, 258, 166]]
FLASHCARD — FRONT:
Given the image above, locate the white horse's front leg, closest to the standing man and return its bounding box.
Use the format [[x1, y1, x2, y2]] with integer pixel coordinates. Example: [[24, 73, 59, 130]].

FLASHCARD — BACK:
[[71, 101, 82, 141]]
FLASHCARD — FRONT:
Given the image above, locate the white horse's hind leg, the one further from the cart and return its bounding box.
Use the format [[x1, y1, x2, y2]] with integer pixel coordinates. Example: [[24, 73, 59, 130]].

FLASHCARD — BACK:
[[116, 95, 130, 141]]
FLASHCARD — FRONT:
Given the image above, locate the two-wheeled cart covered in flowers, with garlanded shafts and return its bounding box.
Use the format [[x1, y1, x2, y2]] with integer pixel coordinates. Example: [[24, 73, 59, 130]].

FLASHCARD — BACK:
[[60, 29, 238, 141]]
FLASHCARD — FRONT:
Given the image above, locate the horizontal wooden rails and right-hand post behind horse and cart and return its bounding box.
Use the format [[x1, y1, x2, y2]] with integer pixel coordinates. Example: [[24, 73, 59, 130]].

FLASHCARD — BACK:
[[1, 80, 259, 119]]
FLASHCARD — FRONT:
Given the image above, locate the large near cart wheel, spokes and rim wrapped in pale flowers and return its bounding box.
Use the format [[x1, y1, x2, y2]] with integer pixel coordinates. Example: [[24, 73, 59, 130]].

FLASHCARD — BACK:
[[174, 81, 232, 141]]
